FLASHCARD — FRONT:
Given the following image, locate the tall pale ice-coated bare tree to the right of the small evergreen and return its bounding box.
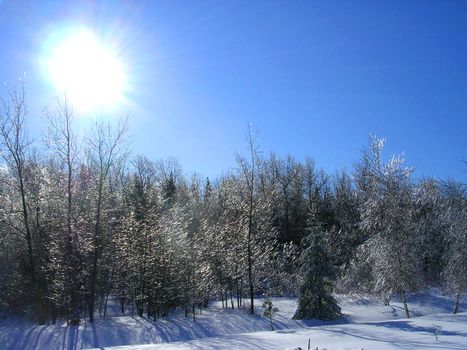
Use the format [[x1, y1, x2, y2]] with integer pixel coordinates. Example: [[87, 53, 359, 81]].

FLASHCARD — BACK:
[[357, 136, 422, 318]]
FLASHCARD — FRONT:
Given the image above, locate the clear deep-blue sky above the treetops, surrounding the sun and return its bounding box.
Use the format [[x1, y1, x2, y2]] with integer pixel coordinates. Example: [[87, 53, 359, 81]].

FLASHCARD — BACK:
[[0, 0, 467, 182]]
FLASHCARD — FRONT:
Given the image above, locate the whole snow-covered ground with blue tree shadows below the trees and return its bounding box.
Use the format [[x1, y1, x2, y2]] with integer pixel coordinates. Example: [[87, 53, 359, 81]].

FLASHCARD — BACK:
[[0, 290, 467, 350]]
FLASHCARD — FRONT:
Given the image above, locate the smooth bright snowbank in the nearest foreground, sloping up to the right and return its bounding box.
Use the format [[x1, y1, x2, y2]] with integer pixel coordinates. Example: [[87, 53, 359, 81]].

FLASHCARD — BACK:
[[92, 313, 467, 350]]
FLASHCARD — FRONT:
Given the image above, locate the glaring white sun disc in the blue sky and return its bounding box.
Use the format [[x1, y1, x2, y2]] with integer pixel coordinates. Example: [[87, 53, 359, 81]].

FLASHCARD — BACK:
[[44, 29, 126, 111]]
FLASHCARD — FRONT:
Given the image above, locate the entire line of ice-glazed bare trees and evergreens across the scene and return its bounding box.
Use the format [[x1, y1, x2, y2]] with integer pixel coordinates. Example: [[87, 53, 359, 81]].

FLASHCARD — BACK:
[[0, 91, 467, 324]]
